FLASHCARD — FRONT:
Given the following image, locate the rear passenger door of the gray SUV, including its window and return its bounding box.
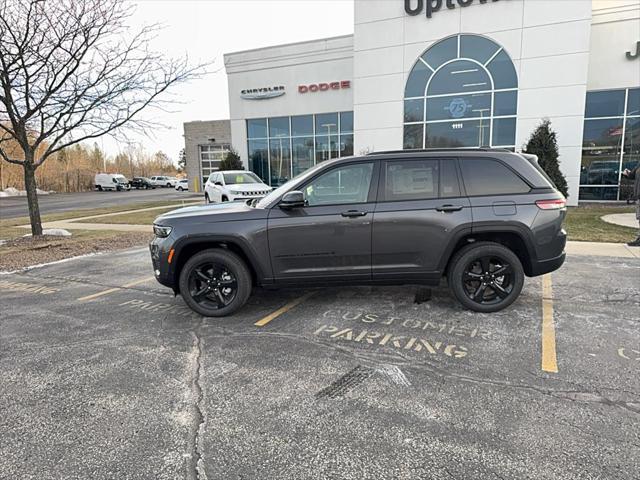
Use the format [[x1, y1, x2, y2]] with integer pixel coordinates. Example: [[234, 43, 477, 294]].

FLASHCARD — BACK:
[[372, 158, 472, 282]]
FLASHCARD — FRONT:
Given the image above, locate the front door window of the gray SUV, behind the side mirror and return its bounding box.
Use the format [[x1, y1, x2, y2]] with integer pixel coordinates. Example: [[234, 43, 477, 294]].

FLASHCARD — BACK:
[[303, 163, 373, 207]]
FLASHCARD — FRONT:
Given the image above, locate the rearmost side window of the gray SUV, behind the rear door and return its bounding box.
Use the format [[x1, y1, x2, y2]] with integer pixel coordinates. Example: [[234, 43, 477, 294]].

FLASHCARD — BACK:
[[460, 158, 531, 197]]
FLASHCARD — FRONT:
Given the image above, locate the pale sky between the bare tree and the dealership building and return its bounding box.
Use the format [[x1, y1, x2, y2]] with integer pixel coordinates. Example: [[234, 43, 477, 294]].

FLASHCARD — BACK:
[[102, 0, 354, 161]]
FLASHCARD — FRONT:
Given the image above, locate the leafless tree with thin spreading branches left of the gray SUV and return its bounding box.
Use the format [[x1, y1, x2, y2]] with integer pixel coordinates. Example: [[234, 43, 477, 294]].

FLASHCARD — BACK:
[[0, 0, 206, 235]]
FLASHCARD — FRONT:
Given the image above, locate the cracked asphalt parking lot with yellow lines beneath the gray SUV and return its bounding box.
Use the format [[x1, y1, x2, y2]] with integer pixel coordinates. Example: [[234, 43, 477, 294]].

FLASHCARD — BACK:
[[0, 249, 640, 480]]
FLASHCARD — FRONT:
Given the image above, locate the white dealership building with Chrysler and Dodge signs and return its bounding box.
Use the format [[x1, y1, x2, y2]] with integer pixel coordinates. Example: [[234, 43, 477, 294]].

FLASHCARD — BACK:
[[185, 0, 640, 204]]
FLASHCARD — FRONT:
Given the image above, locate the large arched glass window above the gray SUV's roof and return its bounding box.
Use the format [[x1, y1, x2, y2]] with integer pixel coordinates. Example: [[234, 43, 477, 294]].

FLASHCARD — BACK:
[[404, 35, 518, 149]]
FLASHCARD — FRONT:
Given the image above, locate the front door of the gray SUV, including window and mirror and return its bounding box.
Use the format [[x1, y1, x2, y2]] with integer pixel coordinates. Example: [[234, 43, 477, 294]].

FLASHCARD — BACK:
[[268, 161, 377, 283]]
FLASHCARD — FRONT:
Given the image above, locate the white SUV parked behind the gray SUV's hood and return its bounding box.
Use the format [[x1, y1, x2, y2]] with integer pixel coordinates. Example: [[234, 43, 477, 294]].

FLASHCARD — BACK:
[[204, 170, 272, 203]]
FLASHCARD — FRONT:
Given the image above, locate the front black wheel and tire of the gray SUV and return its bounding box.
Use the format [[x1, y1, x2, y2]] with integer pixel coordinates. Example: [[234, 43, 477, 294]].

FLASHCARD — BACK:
[[179, 248, 252, 317]]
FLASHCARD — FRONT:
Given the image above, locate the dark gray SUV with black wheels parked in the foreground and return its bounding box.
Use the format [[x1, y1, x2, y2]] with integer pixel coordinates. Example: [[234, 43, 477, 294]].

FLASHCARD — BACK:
[[150, 149, 566, 317]]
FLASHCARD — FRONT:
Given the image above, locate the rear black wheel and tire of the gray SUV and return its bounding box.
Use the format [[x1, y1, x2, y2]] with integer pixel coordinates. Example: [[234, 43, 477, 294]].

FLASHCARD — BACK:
[[447, 242, 524, 313]]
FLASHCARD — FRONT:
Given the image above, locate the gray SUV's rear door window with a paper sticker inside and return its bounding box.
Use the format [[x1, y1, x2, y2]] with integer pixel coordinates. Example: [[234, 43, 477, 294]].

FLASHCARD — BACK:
[[384, 159, 438, 201]]
